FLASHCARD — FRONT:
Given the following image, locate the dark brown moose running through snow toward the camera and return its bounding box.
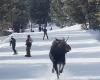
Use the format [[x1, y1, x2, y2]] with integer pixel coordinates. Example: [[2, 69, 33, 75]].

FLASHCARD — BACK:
[[49, 39, 71, 79]]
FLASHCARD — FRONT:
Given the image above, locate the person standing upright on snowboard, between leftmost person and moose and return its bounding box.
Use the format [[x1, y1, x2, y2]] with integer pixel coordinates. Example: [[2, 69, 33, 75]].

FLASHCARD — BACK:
[[25, 35, 32, 57]]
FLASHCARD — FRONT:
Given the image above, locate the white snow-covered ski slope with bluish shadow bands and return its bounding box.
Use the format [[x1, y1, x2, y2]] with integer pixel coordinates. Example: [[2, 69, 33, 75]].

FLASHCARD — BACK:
[[0, 25, 100, 80]]
